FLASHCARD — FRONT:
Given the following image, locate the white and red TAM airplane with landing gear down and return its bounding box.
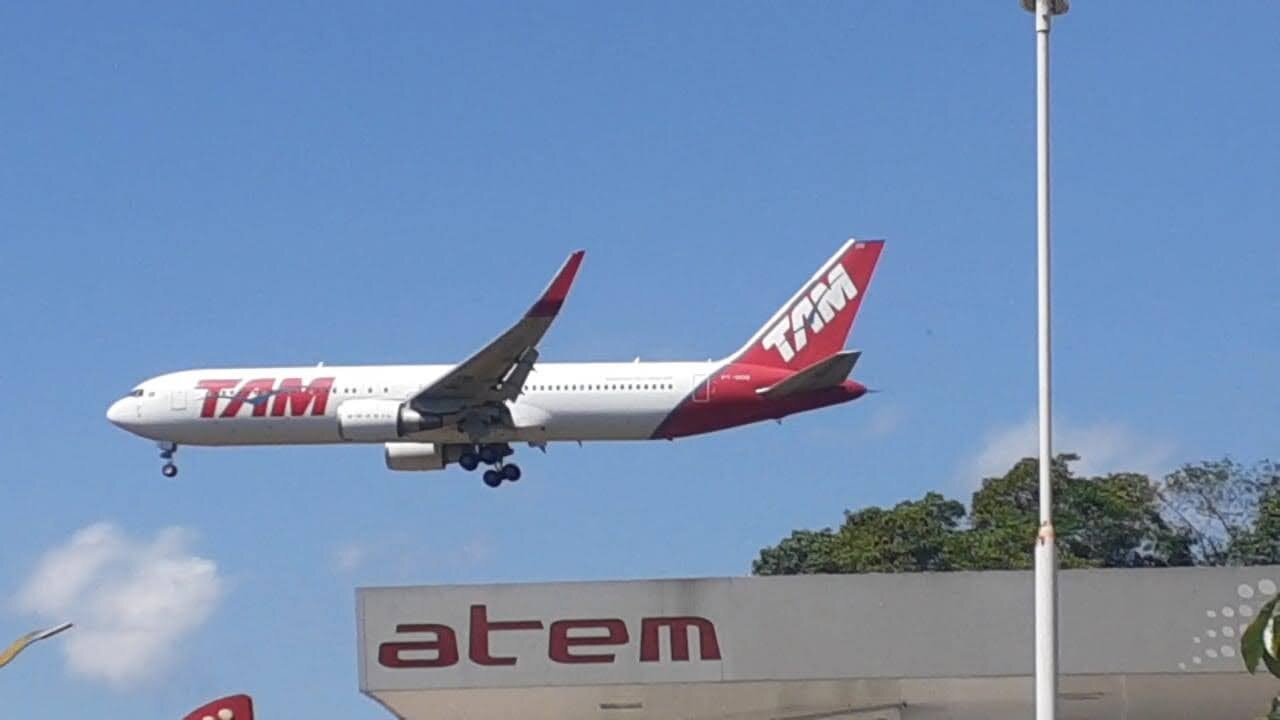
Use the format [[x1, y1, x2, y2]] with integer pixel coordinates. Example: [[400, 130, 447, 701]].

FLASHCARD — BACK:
[[106, 238, 883, 487]]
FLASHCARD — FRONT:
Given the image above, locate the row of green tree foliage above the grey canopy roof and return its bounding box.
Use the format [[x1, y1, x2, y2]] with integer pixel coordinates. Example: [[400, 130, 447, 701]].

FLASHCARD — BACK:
[[751, 455, 1280, 575]]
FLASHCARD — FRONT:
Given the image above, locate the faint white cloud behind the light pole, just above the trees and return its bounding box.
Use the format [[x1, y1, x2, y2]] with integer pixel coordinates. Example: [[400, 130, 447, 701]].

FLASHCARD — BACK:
[[964, 415, 1175, 484]]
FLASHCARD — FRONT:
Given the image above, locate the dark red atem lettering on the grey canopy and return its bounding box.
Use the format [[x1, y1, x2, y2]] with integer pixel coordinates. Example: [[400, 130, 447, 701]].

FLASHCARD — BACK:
[[378, 605, 721, 667]]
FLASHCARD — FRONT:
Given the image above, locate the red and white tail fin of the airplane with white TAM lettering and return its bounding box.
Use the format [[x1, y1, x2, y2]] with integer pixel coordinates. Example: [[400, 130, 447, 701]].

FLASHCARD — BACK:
[[733, 240, 884, 370]]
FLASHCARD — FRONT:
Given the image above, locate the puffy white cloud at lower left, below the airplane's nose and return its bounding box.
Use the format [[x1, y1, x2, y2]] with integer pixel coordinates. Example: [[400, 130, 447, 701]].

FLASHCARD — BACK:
[[14, 523, 224, 687]]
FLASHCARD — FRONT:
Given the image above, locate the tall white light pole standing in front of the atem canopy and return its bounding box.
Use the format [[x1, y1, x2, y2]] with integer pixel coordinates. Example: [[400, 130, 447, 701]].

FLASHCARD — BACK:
[[1021, 0, 1070, 720]]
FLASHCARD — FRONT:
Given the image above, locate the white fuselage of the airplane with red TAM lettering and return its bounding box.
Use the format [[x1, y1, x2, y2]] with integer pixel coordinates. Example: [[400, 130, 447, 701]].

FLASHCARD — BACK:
[[108, 361, 719, 446]]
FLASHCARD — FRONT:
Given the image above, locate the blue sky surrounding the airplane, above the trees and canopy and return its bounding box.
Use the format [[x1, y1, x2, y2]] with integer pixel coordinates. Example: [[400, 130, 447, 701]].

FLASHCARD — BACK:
[[0, 0, 1280, 720]]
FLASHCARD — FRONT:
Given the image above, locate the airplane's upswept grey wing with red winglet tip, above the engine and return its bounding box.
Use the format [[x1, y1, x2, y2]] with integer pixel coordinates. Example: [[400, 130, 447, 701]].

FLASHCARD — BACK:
[[410, 250, 585, 415]]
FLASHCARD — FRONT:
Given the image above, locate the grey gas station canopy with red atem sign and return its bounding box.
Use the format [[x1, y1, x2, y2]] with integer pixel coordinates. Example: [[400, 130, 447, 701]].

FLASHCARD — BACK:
[[357, 566, 1280, 720]]
